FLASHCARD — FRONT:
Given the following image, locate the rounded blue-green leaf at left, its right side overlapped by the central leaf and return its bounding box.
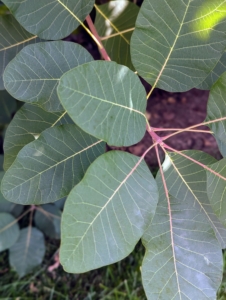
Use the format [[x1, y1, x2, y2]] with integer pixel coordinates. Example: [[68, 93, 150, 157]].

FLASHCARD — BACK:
[[3, 41, 93, 111]]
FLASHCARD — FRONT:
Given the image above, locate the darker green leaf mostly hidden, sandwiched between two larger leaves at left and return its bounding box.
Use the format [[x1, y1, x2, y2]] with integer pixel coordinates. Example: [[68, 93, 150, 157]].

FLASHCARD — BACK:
[[4, 103, 73, 170]]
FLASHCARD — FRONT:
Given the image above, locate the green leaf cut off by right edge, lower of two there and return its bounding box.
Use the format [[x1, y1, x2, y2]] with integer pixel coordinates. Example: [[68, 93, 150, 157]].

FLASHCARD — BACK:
[[206, 158, 226, 226]]
